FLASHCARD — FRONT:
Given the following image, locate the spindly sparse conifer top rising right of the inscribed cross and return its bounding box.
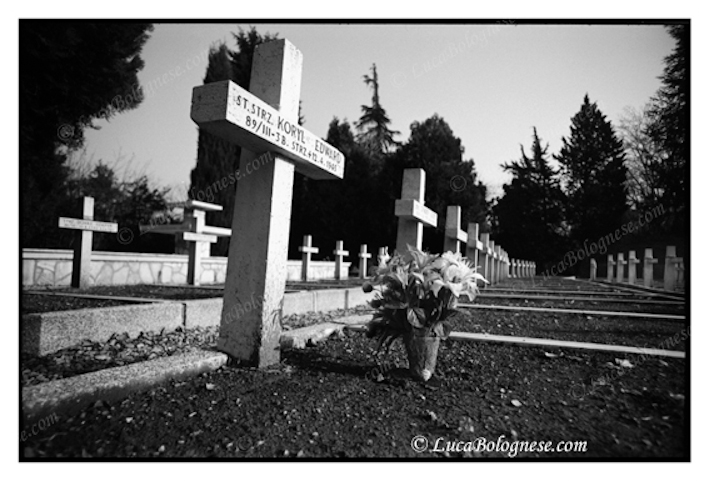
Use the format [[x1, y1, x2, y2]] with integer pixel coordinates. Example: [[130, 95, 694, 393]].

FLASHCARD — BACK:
[[356, 64, 400, 160]]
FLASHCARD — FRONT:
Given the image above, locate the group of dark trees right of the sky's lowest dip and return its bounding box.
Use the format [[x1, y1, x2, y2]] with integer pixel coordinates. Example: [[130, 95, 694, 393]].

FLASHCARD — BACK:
[[492, 24, 689, 274]]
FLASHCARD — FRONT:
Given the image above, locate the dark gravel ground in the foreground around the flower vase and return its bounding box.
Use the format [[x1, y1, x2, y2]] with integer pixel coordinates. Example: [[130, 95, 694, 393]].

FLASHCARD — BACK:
[[20, 333, 690, 460]]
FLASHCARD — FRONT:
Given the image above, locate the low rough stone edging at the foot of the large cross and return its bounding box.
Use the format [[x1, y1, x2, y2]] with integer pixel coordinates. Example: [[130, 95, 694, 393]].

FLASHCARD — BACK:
[[22, 315, 371, 423]]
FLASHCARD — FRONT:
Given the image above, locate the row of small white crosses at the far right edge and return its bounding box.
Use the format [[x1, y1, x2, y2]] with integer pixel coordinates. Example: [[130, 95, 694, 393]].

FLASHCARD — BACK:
[[591, 246, 684, 291]]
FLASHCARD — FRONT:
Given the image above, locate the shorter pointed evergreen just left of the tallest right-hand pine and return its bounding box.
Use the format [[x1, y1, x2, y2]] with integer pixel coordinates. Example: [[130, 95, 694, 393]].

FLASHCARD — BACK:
[[493, 127, 565, 269]]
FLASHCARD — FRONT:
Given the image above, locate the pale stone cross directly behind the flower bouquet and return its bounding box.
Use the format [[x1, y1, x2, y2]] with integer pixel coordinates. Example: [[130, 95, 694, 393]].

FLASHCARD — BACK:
[[394, 169, 438, 254]]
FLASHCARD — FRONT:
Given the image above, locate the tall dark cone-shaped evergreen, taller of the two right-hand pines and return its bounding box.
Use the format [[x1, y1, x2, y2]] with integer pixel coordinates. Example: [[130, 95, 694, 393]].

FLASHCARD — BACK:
[[554, 95, 627, 244]]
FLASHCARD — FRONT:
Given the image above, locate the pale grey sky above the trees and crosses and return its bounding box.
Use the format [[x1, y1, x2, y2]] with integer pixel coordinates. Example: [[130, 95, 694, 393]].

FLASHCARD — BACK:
[[77, 22, 674, 199]]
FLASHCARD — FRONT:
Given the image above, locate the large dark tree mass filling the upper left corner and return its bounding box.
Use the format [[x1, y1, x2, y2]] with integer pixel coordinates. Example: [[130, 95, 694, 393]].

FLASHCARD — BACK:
[[19, 20, 152, 247]]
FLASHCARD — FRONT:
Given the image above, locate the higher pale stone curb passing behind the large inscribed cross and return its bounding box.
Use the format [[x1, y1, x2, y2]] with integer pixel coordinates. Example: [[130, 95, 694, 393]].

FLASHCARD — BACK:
[[21, 287, 374, 355]]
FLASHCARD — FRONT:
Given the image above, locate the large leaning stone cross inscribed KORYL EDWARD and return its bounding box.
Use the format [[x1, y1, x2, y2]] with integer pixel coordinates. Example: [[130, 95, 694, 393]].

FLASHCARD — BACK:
[[191, 39, 345, 367]]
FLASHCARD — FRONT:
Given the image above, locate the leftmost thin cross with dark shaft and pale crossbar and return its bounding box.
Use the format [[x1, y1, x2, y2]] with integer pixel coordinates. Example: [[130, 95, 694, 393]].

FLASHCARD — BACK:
[[59, 197, 118, 288]]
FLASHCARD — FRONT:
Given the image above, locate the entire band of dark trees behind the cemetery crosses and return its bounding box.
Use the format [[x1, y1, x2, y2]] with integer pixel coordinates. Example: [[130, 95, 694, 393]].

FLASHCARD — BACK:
[[20, 21, 689, 278]]
